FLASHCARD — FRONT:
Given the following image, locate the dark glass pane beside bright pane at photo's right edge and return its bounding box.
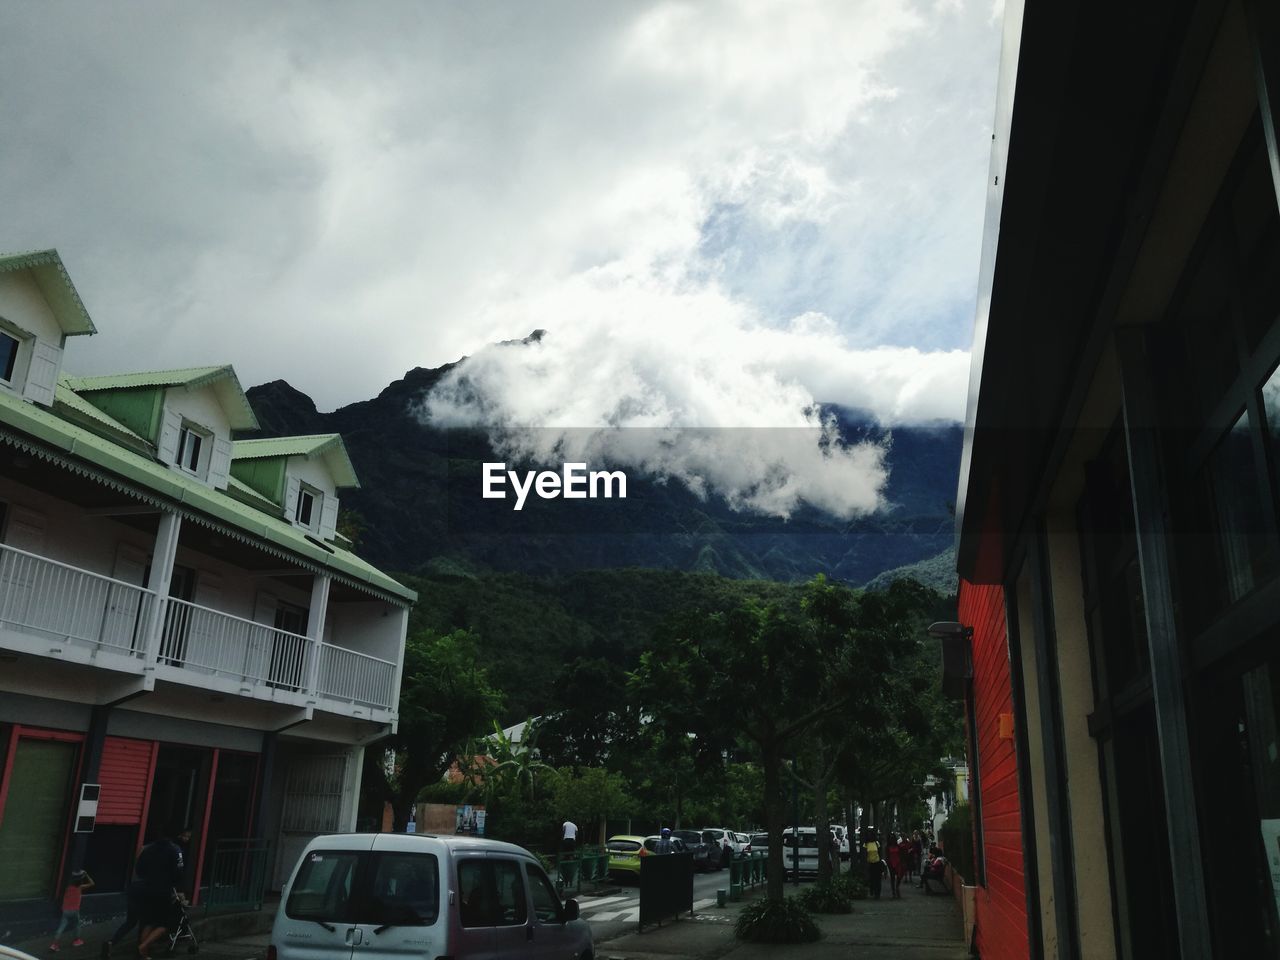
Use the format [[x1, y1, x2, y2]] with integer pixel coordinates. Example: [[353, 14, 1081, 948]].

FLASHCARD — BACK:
[[1206, 411, 1274, 603]]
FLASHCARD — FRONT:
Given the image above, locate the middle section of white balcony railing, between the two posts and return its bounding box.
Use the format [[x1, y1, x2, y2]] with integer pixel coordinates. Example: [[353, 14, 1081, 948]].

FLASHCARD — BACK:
[[160, 596, 311, 690]]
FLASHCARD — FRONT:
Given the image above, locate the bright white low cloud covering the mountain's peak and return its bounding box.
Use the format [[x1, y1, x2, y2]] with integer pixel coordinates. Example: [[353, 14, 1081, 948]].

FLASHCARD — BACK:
[[421, 264, 968, 518]]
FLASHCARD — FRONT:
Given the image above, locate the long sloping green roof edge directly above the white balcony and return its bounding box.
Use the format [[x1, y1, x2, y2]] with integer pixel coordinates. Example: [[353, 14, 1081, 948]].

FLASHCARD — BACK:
[[0, 378, 417, 603]]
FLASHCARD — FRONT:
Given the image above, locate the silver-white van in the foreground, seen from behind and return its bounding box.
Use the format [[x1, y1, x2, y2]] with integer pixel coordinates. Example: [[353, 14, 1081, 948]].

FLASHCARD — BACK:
[[268, 833, 594, 960]]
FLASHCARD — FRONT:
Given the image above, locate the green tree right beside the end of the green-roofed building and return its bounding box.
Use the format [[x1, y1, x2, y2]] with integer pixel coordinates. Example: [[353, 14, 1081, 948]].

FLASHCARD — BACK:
[[362, 630, 502, 829]]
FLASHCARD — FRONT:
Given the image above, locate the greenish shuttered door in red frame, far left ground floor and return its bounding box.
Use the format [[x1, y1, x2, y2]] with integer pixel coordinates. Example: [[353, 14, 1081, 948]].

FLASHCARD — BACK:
[[0, 736, 79, 900]]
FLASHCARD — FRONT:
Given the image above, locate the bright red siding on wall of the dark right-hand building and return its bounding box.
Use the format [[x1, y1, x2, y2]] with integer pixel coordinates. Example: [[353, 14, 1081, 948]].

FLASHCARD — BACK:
[[960, 580, 1029, 960]]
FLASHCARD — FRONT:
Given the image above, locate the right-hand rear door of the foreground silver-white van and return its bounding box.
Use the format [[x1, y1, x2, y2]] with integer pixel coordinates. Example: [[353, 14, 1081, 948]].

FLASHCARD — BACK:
[[352, 855, 448, 960]]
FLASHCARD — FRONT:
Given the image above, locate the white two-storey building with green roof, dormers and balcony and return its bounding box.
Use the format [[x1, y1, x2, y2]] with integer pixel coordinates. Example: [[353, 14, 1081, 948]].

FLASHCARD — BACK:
[[0, 251, 416, 932]]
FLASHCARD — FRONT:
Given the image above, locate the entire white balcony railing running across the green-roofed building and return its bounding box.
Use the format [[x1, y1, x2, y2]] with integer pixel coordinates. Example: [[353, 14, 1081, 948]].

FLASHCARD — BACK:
[[0, 544, 396, 716]]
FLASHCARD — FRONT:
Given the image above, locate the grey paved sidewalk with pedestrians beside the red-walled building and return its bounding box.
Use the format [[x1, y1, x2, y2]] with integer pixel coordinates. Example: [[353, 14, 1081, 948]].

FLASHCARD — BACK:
[[595, 886, 969, 960]]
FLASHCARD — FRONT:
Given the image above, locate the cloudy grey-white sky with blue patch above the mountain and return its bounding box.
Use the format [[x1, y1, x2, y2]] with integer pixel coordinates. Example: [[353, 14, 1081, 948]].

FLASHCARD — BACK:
[[0, 0, 1001, 519]]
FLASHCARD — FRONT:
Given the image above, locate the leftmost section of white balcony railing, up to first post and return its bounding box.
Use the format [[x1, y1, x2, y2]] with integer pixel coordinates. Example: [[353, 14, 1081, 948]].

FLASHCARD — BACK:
[[0, 544, 155, 659]]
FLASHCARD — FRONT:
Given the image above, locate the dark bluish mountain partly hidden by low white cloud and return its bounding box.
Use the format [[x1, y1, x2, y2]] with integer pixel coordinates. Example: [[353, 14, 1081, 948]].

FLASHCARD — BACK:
[[247, 365, 961, 585]]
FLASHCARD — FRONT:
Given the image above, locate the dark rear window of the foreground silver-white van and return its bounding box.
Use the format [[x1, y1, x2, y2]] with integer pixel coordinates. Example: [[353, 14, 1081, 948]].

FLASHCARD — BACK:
[[284, 850, 440, 927]]
